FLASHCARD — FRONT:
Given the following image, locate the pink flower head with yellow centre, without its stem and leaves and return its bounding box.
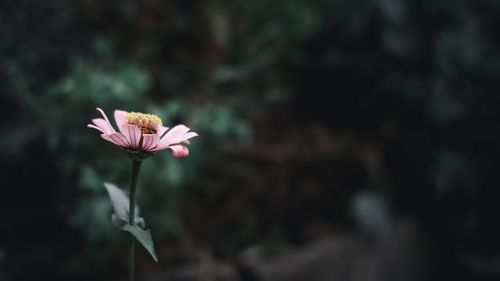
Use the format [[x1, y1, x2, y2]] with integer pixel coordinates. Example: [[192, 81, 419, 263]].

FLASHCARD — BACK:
[[87, 108, 198, 157]]
